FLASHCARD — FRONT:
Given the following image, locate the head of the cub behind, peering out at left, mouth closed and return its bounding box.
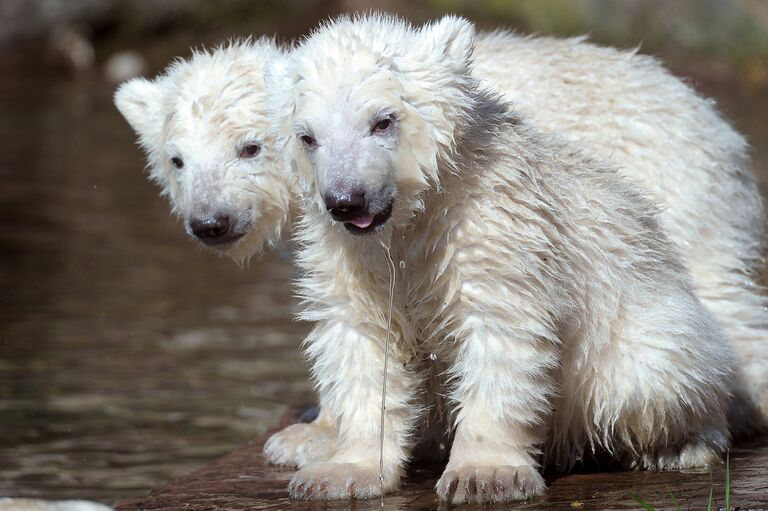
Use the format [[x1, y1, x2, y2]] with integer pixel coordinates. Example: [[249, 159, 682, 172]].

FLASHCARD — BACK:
[[115, 39, 296, 261]]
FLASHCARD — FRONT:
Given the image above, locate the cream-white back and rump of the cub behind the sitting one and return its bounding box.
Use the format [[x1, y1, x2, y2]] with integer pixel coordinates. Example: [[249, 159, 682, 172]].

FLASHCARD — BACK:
[[474, 32, 768, 432]]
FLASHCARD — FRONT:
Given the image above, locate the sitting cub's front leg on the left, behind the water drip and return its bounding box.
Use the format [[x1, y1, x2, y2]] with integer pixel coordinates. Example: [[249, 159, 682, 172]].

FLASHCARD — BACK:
[[288, 321, 418, 500]]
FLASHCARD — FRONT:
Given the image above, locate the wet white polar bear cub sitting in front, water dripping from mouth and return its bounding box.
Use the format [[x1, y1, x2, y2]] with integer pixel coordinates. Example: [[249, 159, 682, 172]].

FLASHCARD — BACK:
[[268, 16, 731, 502]]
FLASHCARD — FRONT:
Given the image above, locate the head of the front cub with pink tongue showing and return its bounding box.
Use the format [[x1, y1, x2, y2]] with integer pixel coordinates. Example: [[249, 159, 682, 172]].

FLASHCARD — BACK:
[[266, 14, 475, 234]]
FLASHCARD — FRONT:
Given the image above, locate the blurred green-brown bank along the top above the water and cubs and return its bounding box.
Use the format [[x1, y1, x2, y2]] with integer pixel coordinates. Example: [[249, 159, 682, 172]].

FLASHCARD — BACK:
[[0, 0, 768, 90]]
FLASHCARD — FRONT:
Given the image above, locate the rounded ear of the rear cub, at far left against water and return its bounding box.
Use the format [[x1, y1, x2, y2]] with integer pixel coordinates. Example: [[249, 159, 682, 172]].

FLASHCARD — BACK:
[[115, 78, 163, 147]]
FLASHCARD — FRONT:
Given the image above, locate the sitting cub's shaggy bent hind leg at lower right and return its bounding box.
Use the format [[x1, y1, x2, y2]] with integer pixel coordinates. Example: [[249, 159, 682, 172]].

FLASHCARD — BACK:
[[555, 279, 732, 470]]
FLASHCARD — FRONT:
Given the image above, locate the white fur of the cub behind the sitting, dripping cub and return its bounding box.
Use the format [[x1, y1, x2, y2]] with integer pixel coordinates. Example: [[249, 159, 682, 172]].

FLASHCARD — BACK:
[[116, 15, 768, 504]]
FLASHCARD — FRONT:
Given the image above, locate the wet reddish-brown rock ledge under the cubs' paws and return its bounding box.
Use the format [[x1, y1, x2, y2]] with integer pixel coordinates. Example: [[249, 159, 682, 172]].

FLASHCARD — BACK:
[[117, 413, 768, 511]]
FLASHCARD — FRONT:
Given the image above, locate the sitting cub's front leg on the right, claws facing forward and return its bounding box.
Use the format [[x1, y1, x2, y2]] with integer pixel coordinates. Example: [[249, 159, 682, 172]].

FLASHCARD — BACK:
[[437, 311, 557, 504]]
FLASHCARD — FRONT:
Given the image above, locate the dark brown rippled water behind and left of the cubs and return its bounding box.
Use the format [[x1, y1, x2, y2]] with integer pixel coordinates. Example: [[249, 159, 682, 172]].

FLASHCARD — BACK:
[[0, 65, 768, 502]]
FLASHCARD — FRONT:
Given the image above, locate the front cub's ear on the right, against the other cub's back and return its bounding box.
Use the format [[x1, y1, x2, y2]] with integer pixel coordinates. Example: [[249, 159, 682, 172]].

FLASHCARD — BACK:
[[422, 16, 475, 71]]
